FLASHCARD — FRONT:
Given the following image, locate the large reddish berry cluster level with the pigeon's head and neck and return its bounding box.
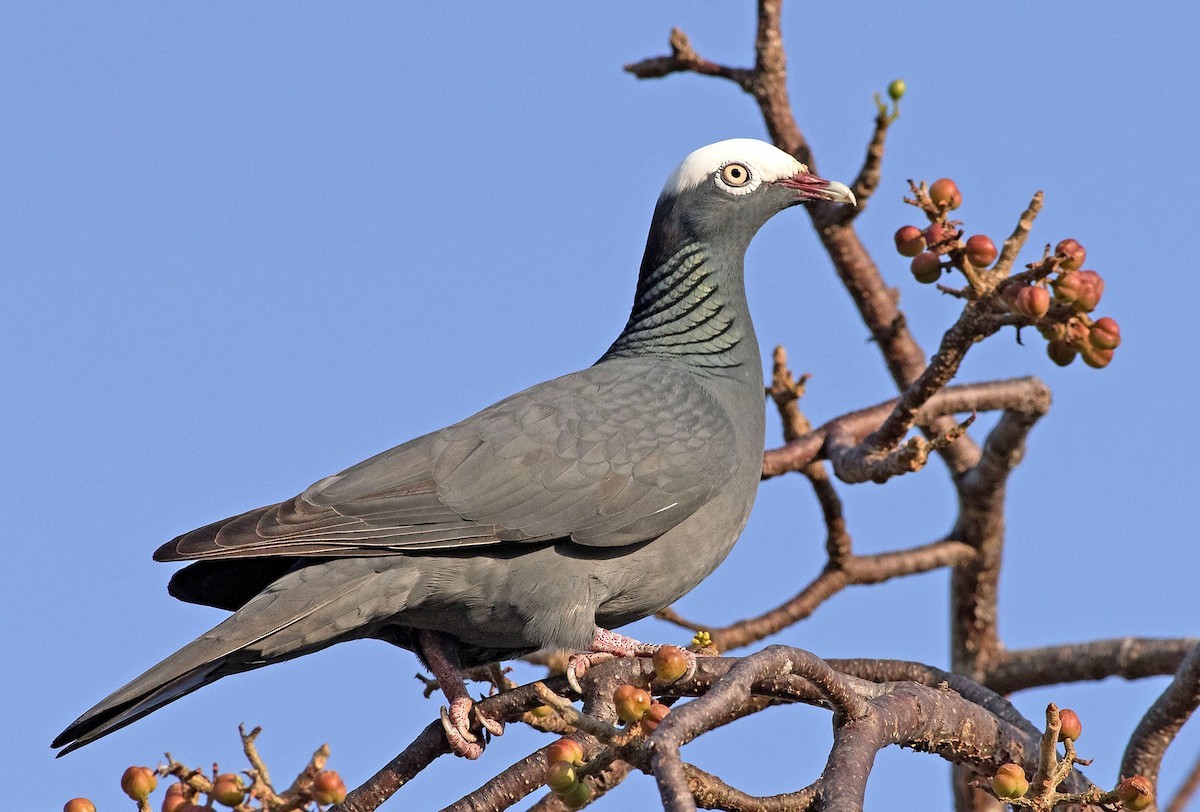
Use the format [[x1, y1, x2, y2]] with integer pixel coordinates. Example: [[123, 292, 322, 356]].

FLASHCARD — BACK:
[[894, 178, 1121, 368]]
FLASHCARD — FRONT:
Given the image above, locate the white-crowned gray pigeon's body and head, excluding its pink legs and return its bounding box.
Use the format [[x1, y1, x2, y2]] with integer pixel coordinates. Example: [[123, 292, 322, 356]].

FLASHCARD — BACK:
[[53, 139, 853, 754]]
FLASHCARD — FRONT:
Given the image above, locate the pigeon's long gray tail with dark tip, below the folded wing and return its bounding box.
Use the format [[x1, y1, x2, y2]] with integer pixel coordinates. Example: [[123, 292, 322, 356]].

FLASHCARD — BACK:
[[50, 566, 379, 756]]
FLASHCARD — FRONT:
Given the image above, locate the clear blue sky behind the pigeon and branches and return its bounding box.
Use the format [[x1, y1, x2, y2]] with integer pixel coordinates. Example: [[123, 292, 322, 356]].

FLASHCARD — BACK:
[[0, 2, 1200, 810]]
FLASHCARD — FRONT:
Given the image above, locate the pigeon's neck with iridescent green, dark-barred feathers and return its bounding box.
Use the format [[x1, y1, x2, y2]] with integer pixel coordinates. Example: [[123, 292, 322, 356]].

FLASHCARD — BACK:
[[601, 233, 762, 374]]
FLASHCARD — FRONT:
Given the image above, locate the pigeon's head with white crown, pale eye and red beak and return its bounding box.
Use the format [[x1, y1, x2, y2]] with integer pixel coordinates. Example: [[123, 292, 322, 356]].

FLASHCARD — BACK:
[[658, 138, 856, 241]]
